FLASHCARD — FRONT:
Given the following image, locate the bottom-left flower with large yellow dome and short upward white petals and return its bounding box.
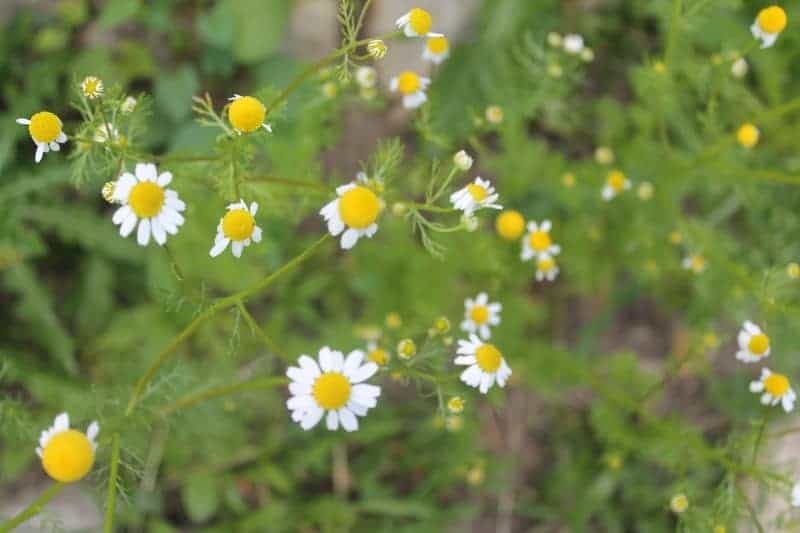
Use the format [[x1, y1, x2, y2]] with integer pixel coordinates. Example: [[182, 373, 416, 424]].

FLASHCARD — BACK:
[[36, 413, 100, 483]]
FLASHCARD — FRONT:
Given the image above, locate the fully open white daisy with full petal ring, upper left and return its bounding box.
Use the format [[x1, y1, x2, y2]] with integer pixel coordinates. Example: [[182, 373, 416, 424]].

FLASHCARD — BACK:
[[112, 163, 186, 246]]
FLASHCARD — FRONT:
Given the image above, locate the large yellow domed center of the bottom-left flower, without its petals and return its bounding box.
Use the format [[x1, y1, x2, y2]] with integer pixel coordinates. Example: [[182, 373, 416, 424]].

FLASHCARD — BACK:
[[42, 429, 94, 483]]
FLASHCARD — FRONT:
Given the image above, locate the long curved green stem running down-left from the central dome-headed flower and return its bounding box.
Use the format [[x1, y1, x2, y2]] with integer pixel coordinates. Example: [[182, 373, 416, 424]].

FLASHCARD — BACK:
[[125, 233, 330, 416]]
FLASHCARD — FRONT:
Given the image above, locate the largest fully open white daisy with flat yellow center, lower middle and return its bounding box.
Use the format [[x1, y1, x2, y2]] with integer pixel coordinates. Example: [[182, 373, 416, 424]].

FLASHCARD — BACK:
[[286, 346, 381, 431]]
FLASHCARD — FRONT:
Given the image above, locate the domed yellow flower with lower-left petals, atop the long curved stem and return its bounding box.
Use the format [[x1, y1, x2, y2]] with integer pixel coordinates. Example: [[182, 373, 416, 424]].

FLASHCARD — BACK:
[[319, 173, 383, 250]]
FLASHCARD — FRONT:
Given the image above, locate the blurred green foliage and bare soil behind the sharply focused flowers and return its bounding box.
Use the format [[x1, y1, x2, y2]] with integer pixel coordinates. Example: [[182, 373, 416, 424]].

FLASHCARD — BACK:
[[0, 0, 800, 532]]
